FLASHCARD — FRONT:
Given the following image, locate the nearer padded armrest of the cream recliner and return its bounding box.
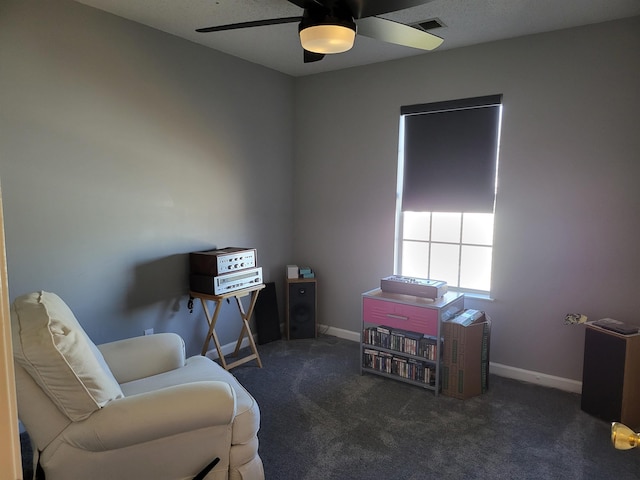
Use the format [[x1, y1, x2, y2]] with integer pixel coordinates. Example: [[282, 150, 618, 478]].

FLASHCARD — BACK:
[[62, 381, 236, 452]]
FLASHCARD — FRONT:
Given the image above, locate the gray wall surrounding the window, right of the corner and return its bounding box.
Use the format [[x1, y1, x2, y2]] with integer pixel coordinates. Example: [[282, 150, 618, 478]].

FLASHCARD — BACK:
[[294, 18, 640, 380]]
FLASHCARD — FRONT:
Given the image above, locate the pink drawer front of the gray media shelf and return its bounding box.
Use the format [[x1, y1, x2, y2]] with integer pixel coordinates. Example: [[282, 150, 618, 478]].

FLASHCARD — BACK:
[[362, 297, 438, 336]]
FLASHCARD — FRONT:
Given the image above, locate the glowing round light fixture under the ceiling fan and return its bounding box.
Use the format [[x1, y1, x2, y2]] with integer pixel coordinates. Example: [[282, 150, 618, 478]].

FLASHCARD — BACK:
[[299, 19, 356, 54]]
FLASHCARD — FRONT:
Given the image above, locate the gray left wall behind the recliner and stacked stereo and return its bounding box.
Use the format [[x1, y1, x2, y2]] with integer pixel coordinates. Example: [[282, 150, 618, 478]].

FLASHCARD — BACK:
[[0, 0, 293, 353]]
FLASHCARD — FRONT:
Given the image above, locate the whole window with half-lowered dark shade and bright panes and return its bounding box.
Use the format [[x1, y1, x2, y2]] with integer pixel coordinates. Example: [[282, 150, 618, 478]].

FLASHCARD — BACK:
[[395, 95, 502, 294]]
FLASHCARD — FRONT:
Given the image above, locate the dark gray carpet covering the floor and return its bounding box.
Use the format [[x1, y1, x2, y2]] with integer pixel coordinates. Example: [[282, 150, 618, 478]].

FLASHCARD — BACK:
[[20, 336, 640, 480]]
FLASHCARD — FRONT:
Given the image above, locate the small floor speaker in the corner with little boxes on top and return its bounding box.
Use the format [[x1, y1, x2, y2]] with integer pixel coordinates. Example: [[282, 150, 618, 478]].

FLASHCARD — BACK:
[[287, 279, 316, 339]]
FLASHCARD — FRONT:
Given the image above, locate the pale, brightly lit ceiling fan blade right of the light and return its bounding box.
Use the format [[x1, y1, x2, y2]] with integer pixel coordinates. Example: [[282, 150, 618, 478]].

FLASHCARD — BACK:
[[356, 17, 443, 50]]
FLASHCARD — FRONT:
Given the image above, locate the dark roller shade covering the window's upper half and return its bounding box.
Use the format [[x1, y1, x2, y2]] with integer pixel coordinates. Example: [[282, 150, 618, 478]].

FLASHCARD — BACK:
[[401, 95, 502, 213]]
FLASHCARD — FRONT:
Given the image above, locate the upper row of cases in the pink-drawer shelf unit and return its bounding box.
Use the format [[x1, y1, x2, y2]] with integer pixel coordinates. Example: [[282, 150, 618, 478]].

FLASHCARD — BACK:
[[362, 326, 438, 360]]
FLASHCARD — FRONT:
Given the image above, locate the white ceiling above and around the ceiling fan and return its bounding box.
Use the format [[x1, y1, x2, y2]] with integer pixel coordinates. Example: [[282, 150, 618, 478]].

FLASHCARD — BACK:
[[76, 0, 640, 76]]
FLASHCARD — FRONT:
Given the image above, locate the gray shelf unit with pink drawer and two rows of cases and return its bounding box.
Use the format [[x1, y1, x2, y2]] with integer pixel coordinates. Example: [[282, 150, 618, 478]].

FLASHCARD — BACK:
[[360, 288, 464, 395]]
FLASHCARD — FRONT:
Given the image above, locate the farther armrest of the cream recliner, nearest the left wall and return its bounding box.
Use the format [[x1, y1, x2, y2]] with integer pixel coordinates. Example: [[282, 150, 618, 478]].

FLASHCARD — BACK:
[[98, 333, 185, 384]]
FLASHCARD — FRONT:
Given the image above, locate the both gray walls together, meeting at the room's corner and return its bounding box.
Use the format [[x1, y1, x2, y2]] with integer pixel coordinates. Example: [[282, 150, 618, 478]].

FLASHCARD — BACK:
[[0, 0, 640, 380]]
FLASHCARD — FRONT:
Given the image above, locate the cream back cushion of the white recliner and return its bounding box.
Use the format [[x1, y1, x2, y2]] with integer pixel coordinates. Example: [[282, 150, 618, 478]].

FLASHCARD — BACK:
[[11, 292, 124, 421]]
